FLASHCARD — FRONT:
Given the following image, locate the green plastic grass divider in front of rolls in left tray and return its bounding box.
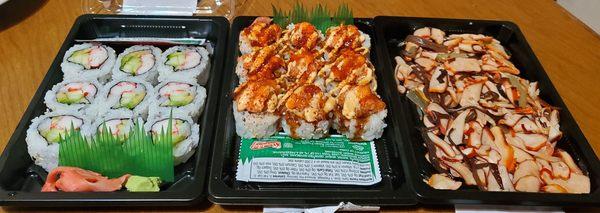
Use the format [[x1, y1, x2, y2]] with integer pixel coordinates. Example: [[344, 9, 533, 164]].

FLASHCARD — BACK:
[[59, 119, 174, 182]]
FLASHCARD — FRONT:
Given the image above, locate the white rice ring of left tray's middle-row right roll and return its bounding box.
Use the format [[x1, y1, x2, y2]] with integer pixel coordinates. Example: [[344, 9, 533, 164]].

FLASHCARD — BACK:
[[149, 76, 206, 121]]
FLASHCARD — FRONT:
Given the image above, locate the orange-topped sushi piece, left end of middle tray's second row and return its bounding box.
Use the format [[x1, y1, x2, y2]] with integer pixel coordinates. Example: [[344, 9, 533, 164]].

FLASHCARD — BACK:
[[235, 46, 285, 83]]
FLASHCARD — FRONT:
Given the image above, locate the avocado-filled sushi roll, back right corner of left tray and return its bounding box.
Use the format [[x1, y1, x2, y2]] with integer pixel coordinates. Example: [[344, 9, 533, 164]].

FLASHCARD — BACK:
[[158, 46, 210, 85]]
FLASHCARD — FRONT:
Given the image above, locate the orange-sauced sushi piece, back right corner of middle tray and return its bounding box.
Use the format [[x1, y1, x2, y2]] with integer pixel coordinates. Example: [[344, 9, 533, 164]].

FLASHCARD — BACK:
[[323, 25, 371, 60]]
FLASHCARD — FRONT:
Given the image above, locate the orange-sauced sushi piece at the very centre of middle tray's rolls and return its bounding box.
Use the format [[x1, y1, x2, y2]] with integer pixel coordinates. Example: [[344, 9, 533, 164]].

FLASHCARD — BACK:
[[284, 49, 324, 89]]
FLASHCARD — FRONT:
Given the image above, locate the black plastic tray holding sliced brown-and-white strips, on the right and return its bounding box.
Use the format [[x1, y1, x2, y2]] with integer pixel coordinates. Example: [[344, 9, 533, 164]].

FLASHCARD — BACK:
[[375, 16, 600, 206]]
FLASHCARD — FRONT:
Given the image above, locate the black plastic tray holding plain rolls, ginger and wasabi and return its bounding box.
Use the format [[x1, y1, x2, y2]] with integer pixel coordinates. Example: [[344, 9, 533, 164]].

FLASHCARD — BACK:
[[0, 15, 229, 206]]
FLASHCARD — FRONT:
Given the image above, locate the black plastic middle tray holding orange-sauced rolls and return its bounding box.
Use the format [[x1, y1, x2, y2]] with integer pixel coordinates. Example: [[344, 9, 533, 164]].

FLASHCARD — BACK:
[[208, 17, 416, 206]]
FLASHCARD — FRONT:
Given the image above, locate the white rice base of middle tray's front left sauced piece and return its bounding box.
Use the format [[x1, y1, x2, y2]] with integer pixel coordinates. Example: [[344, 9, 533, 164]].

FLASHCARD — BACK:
[[233, 103, 280, 138]]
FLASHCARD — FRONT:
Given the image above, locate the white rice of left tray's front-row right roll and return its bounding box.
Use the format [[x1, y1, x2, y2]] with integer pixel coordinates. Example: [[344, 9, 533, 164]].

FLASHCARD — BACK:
[[144, 113, 200, 165]]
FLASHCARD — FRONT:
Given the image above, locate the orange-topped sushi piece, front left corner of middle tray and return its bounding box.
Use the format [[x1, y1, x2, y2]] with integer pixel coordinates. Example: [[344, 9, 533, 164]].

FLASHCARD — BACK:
[[233, 79, 281, 138]]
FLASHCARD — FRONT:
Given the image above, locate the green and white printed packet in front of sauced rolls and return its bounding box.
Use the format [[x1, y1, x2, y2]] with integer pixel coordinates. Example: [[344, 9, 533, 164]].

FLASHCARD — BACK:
[[236, 133, 381, 186]]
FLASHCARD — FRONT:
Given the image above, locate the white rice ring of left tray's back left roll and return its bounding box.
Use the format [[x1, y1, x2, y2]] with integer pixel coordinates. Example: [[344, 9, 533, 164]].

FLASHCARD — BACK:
[[60, 43, 116, 83]]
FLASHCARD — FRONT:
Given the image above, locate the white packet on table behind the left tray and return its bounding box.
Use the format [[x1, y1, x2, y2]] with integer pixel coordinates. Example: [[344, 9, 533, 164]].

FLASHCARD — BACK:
[[121, 0, 198, 16]]
